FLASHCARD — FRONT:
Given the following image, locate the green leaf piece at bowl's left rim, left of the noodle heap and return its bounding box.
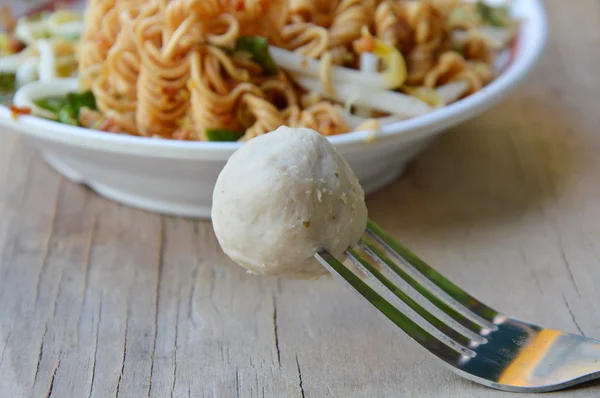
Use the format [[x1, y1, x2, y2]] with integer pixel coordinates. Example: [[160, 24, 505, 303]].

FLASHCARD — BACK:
[[34, 91, 98, 126]]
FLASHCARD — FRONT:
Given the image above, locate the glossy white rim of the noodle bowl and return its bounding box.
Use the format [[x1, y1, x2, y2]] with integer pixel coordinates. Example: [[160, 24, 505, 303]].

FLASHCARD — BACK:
[[0, 0, 548, 159]]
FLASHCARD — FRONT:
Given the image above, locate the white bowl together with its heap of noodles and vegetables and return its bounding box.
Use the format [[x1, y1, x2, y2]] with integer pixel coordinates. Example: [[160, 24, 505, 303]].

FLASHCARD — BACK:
[[0, 0, 546, 217]]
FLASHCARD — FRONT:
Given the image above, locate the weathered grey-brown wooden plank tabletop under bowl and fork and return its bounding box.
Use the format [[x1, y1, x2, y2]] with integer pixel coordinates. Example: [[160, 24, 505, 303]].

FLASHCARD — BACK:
[[0, 0, 600, 398]]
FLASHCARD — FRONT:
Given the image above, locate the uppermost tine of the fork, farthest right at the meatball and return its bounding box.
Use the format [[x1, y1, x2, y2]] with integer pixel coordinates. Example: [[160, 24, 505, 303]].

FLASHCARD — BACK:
[[367, 220, 506, 330]]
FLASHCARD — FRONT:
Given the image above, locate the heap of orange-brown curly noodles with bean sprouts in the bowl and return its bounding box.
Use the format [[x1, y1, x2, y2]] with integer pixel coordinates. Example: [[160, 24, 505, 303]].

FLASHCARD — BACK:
[[34, 0, 516, 141]]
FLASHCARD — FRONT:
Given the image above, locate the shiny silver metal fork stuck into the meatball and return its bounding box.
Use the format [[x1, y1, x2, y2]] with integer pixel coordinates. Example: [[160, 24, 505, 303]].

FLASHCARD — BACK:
[[315, 220, 600, 392]]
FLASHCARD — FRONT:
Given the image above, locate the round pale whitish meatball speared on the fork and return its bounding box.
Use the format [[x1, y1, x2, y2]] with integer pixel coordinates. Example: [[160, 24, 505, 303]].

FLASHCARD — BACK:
[[212, 126, 367, 279]]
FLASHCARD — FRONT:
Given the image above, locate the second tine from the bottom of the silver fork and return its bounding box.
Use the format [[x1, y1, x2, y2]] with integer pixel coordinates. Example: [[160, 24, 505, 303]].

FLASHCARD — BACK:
[[347, 249, 486, 347]]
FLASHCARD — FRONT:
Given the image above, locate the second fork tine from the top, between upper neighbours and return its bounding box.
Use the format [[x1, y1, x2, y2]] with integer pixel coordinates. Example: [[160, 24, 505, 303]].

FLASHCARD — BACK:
[[349, 238, 486, 343]]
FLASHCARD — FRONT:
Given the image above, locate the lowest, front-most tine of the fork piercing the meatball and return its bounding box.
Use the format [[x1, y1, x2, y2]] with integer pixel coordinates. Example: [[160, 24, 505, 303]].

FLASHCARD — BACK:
[[315, 251, 475, 362]]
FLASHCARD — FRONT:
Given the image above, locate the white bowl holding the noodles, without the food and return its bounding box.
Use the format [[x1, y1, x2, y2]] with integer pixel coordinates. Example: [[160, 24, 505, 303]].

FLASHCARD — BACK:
[[0, 0, 547, 218]]
